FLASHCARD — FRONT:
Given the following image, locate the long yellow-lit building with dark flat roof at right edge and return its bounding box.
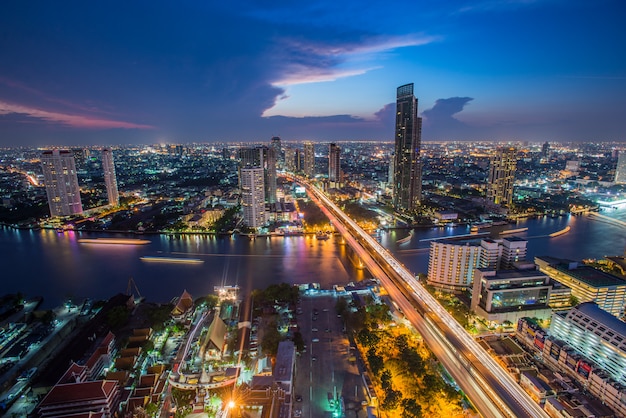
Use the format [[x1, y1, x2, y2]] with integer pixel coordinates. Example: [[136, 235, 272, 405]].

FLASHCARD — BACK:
[[535, 256, 626, 317]]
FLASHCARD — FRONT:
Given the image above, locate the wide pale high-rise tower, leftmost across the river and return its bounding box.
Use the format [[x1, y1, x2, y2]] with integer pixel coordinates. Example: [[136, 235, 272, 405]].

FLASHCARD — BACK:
[[41, 149, 83, 216]]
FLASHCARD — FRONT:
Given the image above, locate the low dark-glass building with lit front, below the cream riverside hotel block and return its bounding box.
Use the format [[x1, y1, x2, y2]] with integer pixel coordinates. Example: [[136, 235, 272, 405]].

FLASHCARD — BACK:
[[471, 268, 552, 324]]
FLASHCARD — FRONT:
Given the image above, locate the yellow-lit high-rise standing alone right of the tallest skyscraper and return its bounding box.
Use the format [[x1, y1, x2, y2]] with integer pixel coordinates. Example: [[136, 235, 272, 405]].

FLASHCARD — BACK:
[[487, 147, 517, 206]]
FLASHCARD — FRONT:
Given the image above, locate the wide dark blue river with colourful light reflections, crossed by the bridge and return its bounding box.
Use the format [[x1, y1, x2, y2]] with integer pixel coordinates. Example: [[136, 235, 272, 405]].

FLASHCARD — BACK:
[[0, 208, 626, 308]]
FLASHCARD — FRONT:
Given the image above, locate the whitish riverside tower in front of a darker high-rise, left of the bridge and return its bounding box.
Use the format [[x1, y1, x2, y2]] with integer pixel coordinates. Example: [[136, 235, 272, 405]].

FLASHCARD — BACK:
[[240, 167, 265, 228]]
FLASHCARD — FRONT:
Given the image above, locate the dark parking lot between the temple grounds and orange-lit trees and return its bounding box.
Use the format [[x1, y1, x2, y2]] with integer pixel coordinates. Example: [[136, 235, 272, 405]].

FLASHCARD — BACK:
[[293, 295, 367, 418]]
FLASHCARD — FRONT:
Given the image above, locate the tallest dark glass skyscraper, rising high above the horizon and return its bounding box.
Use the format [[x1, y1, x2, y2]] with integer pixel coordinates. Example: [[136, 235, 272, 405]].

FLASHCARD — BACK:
[[393, 83, 422, 211]]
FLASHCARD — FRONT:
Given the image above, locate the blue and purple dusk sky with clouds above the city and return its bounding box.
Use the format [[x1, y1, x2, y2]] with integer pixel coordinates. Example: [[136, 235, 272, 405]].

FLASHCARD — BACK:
[[0, 0, 626, 146]]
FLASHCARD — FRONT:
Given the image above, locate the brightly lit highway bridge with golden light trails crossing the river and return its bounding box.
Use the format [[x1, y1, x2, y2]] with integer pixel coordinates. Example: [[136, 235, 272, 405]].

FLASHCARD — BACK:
[[297, 179, 548, 417]]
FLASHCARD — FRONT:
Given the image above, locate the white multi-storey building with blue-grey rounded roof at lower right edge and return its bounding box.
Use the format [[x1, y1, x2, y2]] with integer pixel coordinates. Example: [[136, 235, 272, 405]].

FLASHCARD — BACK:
[[550, 302, 626, 385]]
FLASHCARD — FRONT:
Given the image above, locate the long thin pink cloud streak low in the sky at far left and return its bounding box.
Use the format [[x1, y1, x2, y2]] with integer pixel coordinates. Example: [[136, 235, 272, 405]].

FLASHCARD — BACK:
[[0, 101, 154, 129]]
